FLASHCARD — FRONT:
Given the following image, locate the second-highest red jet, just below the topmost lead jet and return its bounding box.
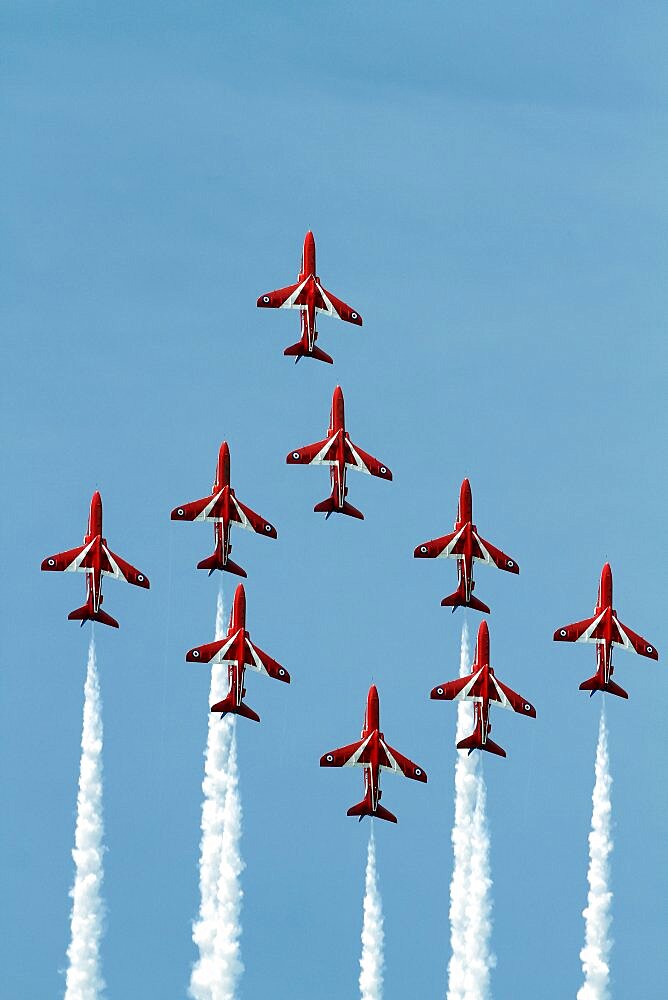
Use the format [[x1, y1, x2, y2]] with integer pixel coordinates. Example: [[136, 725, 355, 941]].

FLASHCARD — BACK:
[[285, 385, 392, 521]]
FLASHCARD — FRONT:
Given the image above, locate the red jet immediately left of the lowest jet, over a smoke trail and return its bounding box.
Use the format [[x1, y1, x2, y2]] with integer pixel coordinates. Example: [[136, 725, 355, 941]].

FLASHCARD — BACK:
[[186, 583, 290, 722]]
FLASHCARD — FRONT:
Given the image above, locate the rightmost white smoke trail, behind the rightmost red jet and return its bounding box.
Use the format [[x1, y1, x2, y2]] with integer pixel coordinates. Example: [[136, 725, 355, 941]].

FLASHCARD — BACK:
[[577, 703, 612, 1000]]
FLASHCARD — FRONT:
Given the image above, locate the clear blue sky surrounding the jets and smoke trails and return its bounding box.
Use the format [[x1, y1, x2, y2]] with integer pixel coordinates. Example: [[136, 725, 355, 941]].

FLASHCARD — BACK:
[[0, 0, 668, 1000]]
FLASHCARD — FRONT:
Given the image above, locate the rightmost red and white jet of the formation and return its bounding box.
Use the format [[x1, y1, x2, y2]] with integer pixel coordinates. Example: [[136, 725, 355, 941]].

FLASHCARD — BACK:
[[553, 563, 659, 698]]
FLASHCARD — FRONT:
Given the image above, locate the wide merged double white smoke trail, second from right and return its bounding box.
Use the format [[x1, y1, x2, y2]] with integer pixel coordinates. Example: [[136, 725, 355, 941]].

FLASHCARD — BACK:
[[447, 622, 494, 1000]]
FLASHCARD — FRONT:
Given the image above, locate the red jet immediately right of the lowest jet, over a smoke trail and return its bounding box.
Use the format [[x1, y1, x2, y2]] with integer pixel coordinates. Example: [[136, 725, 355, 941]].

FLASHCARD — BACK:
[[431, 620, 536, 757]]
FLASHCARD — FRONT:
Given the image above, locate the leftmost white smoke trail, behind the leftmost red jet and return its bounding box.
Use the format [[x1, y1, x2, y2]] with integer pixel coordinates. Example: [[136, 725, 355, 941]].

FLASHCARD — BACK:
[[65, 635, 104, 1000]]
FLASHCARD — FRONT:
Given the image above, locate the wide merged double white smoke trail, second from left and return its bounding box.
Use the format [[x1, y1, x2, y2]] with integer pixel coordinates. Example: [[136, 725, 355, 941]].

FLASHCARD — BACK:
[[189, 584, 243, 1000]]
